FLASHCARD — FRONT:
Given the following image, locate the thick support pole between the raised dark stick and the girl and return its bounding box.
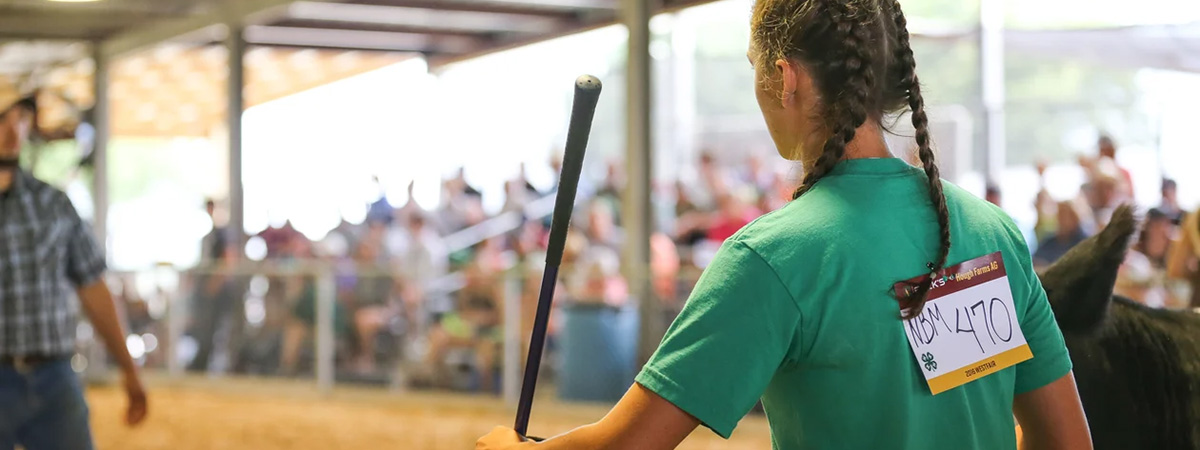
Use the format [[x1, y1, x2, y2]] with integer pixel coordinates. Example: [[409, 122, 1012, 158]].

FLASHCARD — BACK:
[[620, 0, 658, 365]]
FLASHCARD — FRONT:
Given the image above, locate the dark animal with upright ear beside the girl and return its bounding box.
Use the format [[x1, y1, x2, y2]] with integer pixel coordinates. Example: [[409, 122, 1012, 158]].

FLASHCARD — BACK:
[[1040, 208, 1200, 450]]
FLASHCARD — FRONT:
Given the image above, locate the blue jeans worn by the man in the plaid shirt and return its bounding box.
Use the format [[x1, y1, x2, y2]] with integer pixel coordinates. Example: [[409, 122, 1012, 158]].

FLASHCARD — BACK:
[[0, 359, 92, 450]]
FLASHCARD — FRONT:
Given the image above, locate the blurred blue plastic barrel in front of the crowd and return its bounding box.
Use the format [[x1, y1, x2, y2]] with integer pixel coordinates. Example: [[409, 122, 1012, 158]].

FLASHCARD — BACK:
[[558, 304, 638, 402]]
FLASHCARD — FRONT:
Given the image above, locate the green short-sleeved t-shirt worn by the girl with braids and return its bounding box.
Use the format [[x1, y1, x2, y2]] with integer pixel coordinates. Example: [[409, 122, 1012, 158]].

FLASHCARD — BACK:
[[636, 158, 1072, 450]]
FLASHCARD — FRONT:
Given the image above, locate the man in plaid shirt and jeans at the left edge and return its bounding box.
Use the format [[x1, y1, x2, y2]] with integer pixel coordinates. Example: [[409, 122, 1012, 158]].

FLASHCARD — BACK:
[[0, 92, 146, 450]]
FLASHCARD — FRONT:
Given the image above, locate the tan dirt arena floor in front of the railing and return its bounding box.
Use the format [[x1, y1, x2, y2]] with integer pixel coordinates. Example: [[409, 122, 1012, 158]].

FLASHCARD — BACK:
[[88, 379, 770, 450]]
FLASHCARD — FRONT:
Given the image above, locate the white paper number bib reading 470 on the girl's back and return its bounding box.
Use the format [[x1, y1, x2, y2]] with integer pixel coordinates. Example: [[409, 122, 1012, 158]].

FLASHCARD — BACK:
[[895, 252, 1033, 395]]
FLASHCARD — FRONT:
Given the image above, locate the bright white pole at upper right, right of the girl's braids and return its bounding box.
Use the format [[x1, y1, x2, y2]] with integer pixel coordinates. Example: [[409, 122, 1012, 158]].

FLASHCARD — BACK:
[[979, 0, 1008, 185]]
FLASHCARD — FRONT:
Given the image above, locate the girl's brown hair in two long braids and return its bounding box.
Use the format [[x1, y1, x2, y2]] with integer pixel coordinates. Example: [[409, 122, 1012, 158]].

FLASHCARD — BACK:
[[751, 0, 950, 319]]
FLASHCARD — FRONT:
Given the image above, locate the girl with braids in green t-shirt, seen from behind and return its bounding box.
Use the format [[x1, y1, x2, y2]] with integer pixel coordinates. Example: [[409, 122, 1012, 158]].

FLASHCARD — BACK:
[[476, 0, 1091, 450]]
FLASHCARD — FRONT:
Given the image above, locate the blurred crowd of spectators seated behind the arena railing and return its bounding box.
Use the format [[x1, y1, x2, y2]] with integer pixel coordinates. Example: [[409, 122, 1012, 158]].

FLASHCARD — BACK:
[[162, 138, 1200, 392]]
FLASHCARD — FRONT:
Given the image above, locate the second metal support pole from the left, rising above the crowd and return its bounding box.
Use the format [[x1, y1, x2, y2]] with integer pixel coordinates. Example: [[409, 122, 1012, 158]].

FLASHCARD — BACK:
[[226, 23, 246, 250]]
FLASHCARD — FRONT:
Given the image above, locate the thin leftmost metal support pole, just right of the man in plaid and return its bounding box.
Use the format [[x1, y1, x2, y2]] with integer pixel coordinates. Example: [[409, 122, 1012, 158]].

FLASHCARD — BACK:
[[91, 43, 110, 258]]
